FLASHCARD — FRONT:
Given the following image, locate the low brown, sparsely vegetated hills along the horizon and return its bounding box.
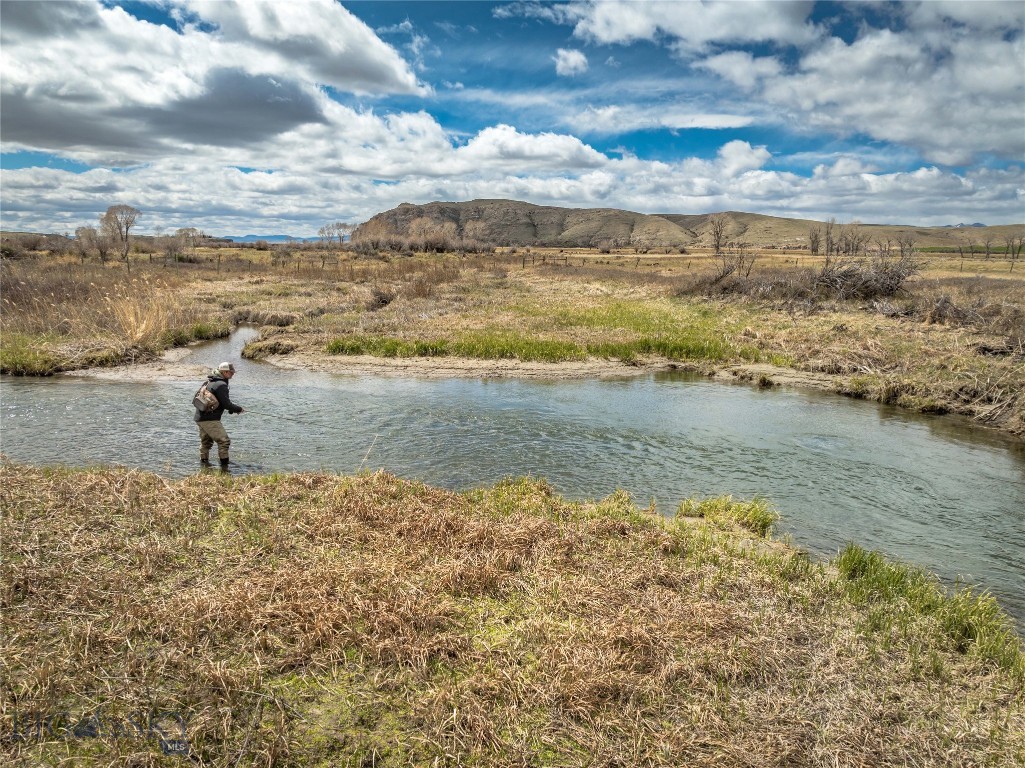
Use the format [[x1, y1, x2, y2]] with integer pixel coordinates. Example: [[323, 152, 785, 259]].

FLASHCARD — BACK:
[[360, 200, 1022, 248]]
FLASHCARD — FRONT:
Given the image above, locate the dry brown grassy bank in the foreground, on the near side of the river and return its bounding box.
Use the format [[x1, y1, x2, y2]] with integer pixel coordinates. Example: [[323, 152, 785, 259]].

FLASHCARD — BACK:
[[0, 466, 1025, 766]]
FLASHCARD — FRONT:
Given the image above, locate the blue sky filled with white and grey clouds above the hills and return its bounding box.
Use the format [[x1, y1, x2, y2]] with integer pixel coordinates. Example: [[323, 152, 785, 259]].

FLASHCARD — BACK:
[[0, 0, 1025, 237]]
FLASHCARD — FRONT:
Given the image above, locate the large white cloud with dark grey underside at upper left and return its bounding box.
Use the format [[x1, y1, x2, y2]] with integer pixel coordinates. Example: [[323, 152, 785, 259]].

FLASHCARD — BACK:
[[0, 0, 427, 165]]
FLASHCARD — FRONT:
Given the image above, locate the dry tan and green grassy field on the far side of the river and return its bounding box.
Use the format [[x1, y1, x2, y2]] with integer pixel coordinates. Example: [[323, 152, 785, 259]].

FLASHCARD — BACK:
[[0, 248, 1025, 435]]
